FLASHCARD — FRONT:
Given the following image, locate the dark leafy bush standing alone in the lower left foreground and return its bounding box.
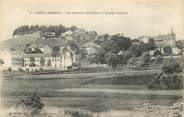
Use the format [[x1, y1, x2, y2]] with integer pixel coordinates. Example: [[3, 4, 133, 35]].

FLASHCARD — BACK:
[[16, 93, 44, 116]]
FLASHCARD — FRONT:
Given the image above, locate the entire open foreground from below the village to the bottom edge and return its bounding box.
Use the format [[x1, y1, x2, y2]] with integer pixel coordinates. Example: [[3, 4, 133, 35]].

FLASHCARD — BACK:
[[1, 70, 183, 117]]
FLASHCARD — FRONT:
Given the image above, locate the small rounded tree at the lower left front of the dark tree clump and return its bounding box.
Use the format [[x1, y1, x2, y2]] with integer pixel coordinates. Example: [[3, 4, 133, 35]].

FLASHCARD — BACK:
[[105, 51, 119, 68]]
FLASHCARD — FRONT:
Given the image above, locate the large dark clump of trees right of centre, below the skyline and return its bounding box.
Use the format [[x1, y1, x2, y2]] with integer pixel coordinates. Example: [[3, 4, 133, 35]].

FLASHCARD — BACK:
[[89, 34, 157, 68]]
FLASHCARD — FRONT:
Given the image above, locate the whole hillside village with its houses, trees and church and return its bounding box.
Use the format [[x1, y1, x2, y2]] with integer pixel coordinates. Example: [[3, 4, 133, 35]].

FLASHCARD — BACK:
[[0, 26, 183, 72]]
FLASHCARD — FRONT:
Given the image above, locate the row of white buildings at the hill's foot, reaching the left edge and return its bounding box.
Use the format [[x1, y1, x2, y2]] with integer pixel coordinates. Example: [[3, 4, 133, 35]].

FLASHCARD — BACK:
[[0, 45, 78, 72]]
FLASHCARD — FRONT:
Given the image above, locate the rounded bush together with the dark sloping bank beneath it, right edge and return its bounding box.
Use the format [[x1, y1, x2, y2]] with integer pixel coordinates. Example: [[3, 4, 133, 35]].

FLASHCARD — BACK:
[[148, 58, 183, 89]]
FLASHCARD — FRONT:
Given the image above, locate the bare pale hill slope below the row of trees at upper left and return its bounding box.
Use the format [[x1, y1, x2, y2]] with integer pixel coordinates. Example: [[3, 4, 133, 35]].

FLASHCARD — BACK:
[[0, 32, 68, 51]]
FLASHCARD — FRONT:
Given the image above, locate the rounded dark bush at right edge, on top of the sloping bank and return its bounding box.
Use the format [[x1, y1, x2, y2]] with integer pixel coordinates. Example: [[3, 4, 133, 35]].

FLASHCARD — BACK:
[[162, 59, 182, 74]]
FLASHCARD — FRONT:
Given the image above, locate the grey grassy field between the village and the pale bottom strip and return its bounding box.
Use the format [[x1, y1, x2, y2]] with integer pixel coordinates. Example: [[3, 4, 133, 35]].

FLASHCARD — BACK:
[[2, 71, 182, 112]]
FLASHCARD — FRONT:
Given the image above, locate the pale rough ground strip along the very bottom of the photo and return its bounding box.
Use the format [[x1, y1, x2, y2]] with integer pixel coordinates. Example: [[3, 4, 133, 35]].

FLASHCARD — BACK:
[[3, 99, 184, 117]]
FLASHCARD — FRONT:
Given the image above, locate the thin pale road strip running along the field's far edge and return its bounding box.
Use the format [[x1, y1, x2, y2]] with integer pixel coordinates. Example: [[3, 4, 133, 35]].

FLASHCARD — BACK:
[[12, 69, 161, 79]]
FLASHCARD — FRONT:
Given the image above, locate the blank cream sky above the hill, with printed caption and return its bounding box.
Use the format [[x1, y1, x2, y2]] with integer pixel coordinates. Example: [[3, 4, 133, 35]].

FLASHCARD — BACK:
[[0, 0, 184, 41]]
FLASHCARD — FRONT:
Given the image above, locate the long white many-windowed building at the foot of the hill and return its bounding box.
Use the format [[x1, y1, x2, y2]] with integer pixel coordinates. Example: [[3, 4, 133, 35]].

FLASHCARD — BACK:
[[23, 46, 77, 72]]
